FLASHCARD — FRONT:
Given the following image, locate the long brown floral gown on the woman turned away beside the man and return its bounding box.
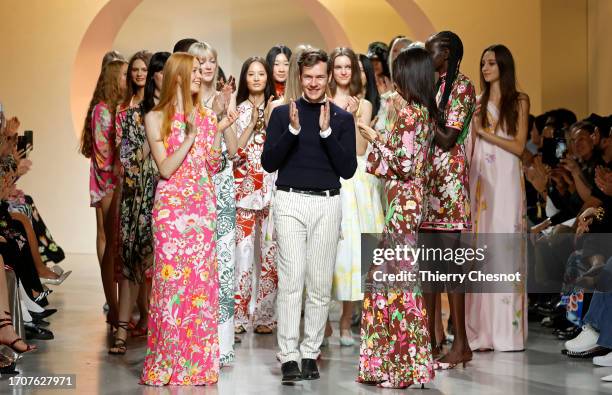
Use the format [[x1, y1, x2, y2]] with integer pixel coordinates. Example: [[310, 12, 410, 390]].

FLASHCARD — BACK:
[[357, 103, 434, 387]]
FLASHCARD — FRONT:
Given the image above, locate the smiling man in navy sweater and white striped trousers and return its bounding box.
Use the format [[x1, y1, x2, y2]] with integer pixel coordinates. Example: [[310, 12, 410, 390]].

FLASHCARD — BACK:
[[261, 49, 357, 383]]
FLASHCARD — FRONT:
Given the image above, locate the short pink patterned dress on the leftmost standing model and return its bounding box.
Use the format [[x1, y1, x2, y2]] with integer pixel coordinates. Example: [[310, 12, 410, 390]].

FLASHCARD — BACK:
[[89, 102, 117, 207]]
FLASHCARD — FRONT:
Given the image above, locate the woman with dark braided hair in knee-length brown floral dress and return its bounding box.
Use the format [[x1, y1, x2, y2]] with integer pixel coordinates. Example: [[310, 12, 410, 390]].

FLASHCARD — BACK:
[[421, 31, 476, 369]]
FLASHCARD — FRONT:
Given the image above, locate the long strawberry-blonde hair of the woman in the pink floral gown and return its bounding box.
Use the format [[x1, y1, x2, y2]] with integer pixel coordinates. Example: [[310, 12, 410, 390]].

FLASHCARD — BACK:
[[152, 52, 200, 143]]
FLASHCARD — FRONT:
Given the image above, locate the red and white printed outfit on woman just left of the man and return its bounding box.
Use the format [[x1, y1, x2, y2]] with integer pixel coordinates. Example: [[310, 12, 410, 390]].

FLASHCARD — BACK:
[[234, 100, 278, 328]]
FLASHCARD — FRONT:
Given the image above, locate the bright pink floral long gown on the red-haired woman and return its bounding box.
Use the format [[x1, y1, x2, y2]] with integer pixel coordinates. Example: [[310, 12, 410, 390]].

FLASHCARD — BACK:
[[141, 108, 221, 385]]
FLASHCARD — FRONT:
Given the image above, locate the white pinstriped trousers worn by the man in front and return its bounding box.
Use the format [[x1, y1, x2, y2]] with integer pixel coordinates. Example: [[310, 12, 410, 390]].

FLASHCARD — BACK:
[[272, 191, 342, 363]]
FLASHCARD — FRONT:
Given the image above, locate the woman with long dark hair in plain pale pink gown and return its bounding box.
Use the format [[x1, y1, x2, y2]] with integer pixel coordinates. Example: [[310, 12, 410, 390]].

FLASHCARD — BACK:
[[465, 45, 529, 351]]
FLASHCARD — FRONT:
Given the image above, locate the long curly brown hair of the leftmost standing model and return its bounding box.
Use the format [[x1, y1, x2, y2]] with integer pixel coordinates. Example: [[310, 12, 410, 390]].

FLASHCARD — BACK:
[[79, 59, 127, 158]]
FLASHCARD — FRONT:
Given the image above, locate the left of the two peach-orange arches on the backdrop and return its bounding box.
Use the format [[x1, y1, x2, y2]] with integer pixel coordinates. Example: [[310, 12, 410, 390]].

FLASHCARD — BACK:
[[70, 0, 350, 138]]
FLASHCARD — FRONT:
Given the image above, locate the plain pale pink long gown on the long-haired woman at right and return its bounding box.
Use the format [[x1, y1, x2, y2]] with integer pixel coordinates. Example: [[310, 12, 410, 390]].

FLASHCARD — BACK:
[[465, 103, 527, 351]]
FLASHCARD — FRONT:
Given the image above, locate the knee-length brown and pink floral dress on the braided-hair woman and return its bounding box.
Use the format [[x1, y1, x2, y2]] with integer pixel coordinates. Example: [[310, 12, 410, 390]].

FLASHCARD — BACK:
[[421, 72, 476, 231]]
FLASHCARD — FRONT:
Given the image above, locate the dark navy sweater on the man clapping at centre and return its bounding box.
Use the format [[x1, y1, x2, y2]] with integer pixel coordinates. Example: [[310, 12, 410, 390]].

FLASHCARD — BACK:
[[261, 98, 357, 191]]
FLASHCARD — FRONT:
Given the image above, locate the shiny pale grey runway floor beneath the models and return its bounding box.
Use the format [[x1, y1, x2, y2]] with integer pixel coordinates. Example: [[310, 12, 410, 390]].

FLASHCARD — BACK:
[[0, 255, 612, 395]]
